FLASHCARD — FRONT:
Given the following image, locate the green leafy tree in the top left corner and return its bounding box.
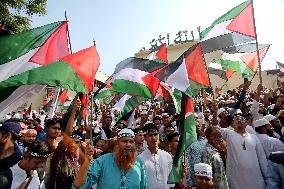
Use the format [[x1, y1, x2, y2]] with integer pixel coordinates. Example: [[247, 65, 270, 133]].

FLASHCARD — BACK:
[[0, 0, 47, 33]]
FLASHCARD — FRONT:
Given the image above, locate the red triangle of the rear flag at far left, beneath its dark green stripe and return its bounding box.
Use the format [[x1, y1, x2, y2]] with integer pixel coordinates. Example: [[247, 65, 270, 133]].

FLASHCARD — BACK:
[[29, 22, 69, 65]]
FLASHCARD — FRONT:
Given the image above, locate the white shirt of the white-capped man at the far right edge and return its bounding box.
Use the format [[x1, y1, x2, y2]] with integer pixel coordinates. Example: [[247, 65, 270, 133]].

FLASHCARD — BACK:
[[256, 134, 284, 159]]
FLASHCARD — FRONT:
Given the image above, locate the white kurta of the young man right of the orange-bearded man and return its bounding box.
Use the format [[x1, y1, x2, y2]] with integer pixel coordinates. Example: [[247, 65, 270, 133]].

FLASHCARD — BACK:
[[138, 148, 173, 189]]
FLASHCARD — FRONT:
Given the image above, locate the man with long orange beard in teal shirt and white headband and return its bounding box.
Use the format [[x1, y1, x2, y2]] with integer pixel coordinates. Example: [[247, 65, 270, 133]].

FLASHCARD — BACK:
[[73, 129, 147, 189]]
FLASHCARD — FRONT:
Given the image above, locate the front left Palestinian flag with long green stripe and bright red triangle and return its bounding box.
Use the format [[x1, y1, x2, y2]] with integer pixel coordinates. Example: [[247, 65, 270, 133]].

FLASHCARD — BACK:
[[0, 46, 100, 93]]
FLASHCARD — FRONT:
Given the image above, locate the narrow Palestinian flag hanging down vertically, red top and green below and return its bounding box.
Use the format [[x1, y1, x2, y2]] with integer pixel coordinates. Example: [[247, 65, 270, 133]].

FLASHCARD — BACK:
[[168, 94, 197, 183]]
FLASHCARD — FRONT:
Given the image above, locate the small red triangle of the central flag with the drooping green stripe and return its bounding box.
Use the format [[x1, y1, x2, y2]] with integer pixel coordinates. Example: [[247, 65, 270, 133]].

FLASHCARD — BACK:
[[142, 68, 162, 96]]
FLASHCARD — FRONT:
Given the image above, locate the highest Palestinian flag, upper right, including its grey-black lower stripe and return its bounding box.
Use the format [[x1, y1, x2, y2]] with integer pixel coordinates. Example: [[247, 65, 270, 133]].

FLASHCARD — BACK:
[[200, 0, 256, 54]]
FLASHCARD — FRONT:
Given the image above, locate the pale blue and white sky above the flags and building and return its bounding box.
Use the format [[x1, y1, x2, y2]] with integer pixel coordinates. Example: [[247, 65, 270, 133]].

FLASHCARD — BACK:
[[32, 0, 284, 75]]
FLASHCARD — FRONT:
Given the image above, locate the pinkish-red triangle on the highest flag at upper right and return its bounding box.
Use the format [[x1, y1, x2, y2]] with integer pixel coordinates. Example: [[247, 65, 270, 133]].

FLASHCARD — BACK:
[[227, 3, 256, 37]]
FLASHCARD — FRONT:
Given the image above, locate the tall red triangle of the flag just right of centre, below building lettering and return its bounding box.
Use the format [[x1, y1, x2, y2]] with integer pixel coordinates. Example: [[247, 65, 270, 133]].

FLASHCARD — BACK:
[[185, 44, 210, 87]]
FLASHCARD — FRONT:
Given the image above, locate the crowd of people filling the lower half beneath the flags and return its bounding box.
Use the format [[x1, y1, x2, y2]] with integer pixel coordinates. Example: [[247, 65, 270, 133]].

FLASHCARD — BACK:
[[0, 82, 284, 189]]
